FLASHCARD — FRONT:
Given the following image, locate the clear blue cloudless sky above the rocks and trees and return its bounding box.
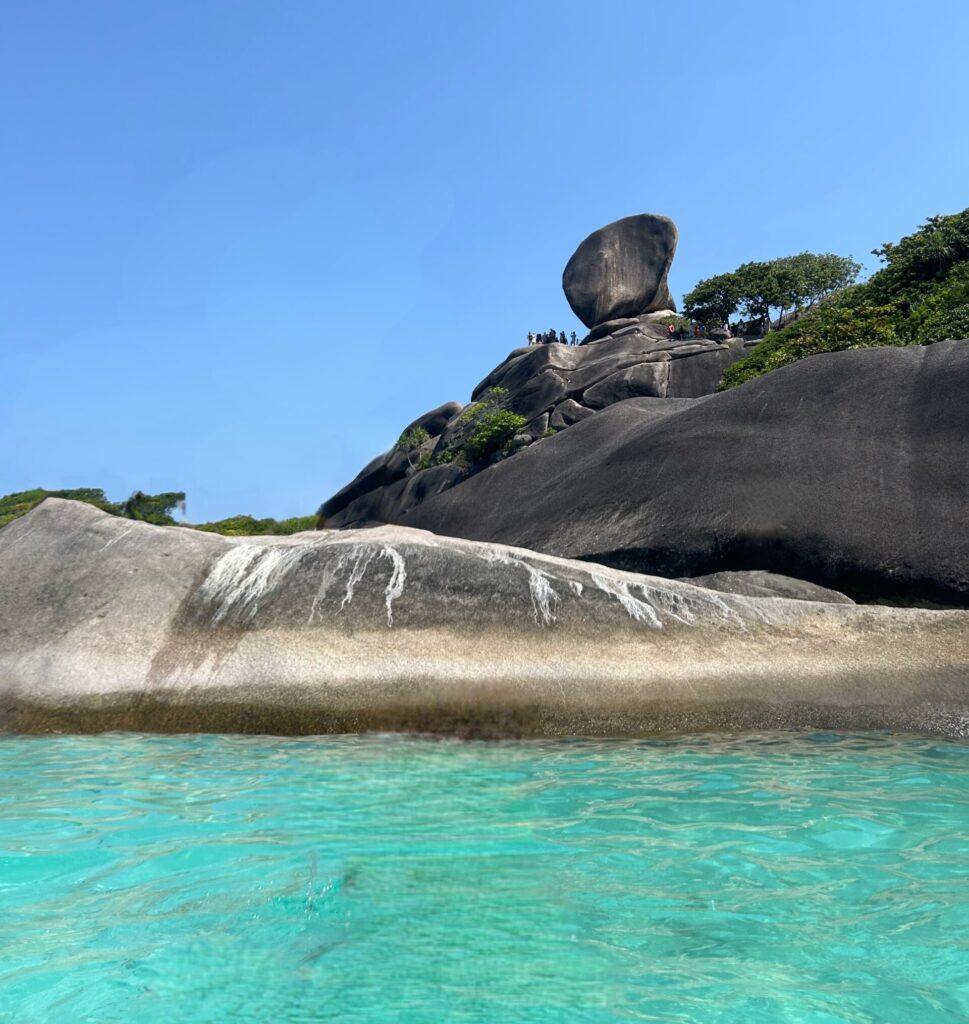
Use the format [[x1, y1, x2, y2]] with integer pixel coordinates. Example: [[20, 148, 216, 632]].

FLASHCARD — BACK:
[[0, 0, 969, 521]]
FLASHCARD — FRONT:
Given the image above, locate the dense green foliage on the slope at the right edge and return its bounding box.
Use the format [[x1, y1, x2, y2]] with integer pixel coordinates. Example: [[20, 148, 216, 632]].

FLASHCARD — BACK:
[[720, 210, 969, 390]]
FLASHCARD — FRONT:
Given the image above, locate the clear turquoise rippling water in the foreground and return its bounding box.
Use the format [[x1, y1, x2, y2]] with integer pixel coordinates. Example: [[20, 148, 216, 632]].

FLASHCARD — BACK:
[[0, 735, 969, 1024]]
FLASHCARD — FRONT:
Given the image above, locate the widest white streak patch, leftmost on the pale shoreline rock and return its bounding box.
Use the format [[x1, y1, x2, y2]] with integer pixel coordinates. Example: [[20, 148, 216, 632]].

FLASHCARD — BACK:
[[199, 544, 306, 626]]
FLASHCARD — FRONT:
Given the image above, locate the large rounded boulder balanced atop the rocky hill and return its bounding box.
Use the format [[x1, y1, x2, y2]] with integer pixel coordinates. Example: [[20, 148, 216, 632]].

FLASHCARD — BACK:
[[562, 213, 677, 328]]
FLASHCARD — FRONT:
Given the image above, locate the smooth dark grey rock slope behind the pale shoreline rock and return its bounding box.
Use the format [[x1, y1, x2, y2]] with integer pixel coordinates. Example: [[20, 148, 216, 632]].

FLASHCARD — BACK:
[[398, 341, 969, 606]]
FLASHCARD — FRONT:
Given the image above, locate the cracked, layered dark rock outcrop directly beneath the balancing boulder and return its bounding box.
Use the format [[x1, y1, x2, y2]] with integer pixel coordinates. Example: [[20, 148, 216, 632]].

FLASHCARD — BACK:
[[320, 319, 745, 527]]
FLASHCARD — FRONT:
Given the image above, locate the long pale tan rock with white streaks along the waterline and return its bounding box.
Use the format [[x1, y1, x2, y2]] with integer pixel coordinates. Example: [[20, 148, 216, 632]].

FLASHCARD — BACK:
[[0, 499, 969, 736]]
